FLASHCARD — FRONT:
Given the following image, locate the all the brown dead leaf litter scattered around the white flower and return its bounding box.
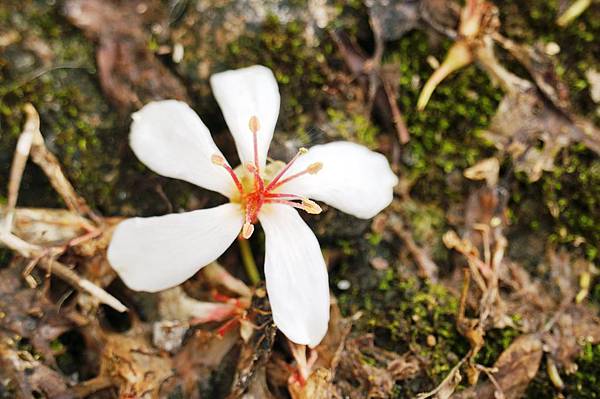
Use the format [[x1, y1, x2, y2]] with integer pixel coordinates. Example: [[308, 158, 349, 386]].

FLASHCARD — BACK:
[[0, 0, 600, 399]]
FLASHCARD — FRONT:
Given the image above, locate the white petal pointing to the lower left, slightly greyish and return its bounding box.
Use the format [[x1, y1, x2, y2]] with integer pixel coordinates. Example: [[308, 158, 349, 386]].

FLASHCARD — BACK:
[[108, 204, 243, 292]]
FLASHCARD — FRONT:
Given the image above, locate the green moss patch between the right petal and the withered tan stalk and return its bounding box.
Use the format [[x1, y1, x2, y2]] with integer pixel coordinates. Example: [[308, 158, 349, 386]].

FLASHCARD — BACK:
[[386, 31, 502, 201]]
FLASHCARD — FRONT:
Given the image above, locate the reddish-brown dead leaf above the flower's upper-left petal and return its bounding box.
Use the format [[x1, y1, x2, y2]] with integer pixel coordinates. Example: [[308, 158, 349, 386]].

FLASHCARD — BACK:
[[64, 0, 189, 111]]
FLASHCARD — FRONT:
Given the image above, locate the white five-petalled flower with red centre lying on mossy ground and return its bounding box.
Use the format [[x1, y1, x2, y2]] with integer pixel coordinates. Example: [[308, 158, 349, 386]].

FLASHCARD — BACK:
[[108, 66, 397, 347]]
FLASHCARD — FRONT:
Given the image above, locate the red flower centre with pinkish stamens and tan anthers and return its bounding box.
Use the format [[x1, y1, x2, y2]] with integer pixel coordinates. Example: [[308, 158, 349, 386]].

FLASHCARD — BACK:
[[211, 116, 323, 239]]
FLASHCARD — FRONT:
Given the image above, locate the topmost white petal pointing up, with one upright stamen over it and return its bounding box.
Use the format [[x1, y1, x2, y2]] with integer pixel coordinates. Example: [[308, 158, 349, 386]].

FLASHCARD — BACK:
[[210, 65, 279, 168]]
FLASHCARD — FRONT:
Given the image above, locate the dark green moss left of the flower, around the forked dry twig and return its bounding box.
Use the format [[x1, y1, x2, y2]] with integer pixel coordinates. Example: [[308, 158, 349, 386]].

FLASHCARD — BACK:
[[0, 0, 211, 219]]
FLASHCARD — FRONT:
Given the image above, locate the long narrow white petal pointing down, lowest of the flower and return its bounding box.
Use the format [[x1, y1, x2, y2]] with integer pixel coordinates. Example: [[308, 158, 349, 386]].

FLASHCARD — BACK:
[[259, 205, 329, 347]]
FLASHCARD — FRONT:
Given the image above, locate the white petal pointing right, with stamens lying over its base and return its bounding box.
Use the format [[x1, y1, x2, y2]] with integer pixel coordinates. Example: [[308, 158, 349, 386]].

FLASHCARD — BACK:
[[278, 141, 398, 219]]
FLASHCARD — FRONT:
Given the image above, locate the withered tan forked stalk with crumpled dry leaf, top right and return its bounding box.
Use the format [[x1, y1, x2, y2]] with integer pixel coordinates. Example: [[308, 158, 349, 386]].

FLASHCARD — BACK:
[[418, 0, 600, 181]]
